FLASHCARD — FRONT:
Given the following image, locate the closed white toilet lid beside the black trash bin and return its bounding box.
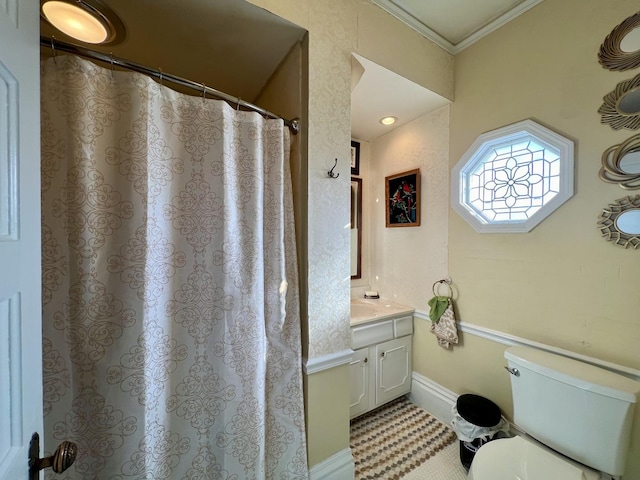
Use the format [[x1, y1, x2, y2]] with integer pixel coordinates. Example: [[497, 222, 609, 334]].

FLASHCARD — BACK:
[[468, 436, 600, 480]]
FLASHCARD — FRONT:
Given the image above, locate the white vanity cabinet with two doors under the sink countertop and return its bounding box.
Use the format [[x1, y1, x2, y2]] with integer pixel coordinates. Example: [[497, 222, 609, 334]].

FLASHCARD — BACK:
[[350, 315, 413, 418]]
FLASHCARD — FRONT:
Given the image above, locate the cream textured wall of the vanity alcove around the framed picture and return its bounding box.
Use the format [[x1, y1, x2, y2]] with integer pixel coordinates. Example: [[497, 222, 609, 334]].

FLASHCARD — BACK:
[[370, 107, 450, 310]]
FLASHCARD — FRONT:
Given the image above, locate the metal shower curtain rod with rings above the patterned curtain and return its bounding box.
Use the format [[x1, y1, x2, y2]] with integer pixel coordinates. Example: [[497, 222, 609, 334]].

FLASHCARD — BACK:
[[40, 37, 300, 134]]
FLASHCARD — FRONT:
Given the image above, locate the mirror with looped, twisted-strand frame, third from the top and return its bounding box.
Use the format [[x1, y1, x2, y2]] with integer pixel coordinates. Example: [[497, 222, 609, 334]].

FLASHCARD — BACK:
[[599, 135, 640, 190]]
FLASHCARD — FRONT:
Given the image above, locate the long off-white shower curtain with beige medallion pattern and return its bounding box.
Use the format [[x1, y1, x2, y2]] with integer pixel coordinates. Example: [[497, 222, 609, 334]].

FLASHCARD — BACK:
[[40, 55, 308, 480]]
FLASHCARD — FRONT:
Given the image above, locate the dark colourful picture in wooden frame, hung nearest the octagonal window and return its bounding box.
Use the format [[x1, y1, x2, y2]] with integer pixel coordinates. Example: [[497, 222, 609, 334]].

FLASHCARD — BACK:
[[384, 168, 420, 228]]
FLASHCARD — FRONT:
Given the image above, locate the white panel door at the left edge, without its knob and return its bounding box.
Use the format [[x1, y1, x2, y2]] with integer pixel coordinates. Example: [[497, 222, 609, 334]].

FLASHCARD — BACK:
[[0, 0, 42, 480]]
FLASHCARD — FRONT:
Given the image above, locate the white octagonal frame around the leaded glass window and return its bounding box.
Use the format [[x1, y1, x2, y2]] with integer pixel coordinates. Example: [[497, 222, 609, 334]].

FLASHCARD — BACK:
[[451, 119, 574, 233]]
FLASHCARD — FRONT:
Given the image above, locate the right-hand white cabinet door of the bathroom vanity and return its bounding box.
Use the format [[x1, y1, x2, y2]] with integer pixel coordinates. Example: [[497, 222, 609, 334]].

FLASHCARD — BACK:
[[375, 335, 411, 406]]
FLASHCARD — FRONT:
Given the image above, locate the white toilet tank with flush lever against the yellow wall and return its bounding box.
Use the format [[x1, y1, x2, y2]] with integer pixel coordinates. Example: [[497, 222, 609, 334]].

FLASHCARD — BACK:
[[504, 347, 640, 475]]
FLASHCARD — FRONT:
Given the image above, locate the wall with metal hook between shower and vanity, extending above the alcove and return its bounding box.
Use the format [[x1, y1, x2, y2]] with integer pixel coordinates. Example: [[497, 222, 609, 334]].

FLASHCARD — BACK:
[[251, 0, 453, 466]]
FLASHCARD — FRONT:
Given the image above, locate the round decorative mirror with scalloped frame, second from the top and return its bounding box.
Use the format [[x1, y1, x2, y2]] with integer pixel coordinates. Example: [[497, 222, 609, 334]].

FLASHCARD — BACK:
[[598, 75, 640, 130]]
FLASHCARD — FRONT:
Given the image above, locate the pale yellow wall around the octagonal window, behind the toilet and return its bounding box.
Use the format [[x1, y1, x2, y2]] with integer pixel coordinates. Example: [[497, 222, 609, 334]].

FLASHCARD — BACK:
[[442, 0, 640, 479]]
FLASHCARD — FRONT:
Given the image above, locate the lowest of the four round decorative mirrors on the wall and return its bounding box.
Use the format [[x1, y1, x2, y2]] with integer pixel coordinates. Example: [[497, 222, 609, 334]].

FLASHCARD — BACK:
[[598, 195, 640, 249]]
